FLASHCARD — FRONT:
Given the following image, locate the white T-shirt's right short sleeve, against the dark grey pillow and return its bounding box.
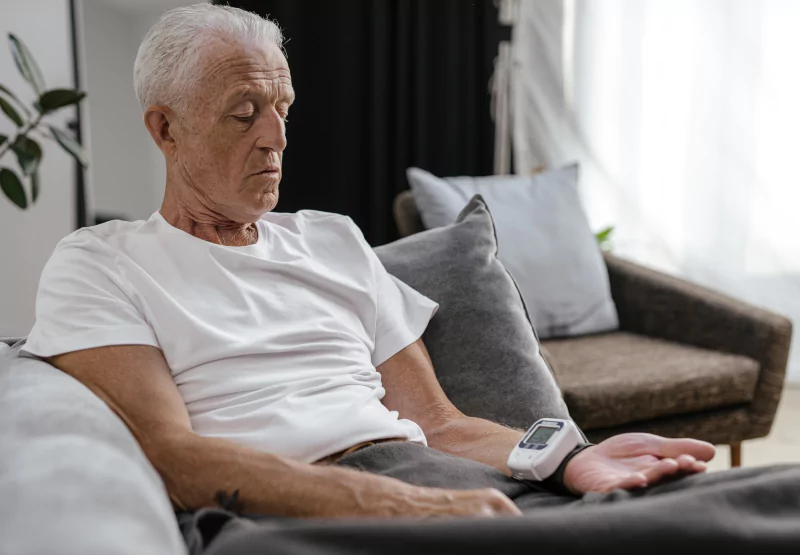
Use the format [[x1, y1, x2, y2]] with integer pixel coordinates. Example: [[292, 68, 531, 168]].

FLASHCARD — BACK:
[[348, 218, 439, 367]]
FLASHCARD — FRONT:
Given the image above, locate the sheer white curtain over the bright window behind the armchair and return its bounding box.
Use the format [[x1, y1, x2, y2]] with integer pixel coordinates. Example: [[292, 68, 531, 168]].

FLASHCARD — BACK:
[[513, 0, 800, 381]]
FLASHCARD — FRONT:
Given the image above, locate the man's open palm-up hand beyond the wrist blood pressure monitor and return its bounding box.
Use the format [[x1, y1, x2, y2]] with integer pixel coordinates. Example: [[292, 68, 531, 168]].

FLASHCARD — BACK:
[[564, 434, 714, 494]]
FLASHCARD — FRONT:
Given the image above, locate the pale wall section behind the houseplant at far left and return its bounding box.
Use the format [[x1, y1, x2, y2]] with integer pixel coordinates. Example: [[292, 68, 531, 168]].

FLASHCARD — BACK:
[[0, 0, 75, 336]]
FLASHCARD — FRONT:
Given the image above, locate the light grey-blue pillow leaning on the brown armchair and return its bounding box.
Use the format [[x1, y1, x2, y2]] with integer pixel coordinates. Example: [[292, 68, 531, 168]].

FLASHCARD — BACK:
[[407, 164, 619, 338]]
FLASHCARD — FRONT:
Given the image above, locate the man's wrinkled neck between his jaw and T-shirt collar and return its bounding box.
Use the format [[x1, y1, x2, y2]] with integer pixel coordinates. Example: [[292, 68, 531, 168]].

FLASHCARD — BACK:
[[160, 179, 258, 247]]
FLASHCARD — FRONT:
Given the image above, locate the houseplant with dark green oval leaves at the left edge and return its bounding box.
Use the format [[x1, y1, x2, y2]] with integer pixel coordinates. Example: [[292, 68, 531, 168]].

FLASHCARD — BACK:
[[0, 33, 89, 210]]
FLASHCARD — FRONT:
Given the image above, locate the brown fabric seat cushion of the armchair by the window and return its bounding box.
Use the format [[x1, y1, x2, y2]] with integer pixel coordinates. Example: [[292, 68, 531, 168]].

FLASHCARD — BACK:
[[544, 332, 759, 430]]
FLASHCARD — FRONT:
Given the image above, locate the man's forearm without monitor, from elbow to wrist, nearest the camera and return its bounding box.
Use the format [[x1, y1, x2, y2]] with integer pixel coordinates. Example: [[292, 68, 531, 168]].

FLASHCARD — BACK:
[[143, 432, 432, 517]]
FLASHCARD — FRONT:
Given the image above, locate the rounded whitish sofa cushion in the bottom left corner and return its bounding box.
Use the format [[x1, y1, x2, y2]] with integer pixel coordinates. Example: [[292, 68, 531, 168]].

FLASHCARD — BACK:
[[0, 343, 186, 555]]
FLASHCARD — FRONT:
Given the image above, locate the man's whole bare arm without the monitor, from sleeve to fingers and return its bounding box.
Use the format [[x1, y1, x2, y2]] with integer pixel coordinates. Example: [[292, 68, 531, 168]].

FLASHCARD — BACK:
[[49, 345, 515, 517]]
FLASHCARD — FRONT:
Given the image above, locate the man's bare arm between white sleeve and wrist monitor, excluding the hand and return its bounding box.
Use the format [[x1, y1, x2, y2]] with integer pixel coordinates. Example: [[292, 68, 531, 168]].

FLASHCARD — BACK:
[[378, 339, 523, 475]]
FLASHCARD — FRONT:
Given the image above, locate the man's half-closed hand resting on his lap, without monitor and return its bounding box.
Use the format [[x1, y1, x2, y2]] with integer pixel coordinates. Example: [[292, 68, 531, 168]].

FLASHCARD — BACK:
[[394, 488, 522, 518]]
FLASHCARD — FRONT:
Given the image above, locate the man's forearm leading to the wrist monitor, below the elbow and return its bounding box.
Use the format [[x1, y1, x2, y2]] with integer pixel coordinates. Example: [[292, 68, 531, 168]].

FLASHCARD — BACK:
[[427, 416, 524, 475]]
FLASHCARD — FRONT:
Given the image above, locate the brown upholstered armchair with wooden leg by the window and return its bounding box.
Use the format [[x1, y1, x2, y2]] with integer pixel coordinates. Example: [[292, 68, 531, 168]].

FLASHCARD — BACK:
[[394, 191, 792, 466]]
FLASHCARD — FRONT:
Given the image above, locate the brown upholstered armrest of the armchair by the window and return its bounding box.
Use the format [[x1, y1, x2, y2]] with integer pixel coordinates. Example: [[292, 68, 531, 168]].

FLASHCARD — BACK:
[[605, 254, 792, 435]]
